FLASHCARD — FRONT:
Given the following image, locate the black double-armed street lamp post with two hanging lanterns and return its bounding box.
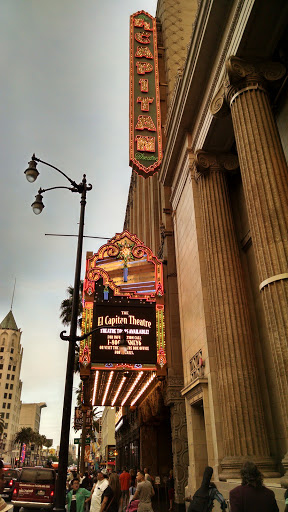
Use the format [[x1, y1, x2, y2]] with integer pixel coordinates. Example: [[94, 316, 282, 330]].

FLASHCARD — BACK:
[[25, 155, 92, 512]]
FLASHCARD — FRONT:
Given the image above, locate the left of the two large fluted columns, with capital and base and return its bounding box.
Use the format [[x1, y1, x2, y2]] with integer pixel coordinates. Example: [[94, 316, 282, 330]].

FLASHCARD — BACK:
[[195, 151, 276, 479]]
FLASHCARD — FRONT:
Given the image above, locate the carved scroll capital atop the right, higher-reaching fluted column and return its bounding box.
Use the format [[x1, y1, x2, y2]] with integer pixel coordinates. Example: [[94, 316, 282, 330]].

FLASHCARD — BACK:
[[210, 56, 286, 118]]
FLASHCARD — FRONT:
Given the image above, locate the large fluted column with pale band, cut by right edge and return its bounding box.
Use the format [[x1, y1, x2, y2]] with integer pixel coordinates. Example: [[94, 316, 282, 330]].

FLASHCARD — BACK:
[[211, 57, 288, 485]]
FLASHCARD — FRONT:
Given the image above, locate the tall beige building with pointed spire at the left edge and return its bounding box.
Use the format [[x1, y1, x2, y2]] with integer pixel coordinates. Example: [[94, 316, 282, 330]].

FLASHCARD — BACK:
[[0, 311, 23, 464]]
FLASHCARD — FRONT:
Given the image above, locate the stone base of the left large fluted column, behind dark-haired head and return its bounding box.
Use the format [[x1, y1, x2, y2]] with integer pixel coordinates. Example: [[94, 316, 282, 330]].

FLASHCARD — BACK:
[[219, 457, 280, 482]]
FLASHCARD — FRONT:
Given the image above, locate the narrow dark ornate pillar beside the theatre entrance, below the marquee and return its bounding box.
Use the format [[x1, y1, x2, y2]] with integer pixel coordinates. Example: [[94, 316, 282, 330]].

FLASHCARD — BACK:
[[165, 376, 189, 511]]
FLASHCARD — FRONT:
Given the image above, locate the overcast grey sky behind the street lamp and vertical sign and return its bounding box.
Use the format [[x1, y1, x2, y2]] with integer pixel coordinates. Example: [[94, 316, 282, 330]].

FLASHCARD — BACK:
[[0, 0, 157, 447]]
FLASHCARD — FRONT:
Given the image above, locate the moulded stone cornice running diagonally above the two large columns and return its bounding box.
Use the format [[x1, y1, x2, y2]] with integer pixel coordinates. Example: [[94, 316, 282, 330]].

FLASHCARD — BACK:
[[159, 0, 288, 186]]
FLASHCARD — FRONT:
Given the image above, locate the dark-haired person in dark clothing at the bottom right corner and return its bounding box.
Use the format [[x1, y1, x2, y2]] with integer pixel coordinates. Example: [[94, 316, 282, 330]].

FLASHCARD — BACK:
[[229, 461, 279, 512]]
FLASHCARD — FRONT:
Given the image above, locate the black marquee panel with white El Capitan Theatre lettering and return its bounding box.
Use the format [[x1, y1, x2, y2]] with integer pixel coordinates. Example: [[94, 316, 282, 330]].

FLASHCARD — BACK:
[[91, 303, 157, 364]]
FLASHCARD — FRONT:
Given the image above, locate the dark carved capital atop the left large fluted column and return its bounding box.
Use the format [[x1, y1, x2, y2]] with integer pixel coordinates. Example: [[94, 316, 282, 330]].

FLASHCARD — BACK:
[[194, 150, 239, 179]]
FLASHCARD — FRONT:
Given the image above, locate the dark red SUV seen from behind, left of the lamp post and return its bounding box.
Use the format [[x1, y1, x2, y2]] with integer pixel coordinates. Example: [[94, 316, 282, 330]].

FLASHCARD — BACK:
[[11, 468, 56, 512]]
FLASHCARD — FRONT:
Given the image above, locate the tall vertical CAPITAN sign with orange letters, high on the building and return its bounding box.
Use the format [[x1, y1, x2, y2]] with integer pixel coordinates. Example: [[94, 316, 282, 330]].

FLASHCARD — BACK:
[[130, 11, 162, 178]]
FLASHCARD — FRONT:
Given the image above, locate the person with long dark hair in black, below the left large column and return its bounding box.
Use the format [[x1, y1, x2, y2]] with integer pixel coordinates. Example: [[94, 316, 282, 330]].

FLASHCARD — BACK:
[[187, 466, 227, 512]]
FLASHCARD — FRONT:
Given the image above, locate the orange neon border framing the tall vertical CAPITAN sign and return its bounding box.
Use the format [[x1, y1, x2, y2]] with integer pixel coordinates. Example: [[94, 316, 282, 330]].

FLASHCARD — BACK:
[[129, 11, 163, 178]]
